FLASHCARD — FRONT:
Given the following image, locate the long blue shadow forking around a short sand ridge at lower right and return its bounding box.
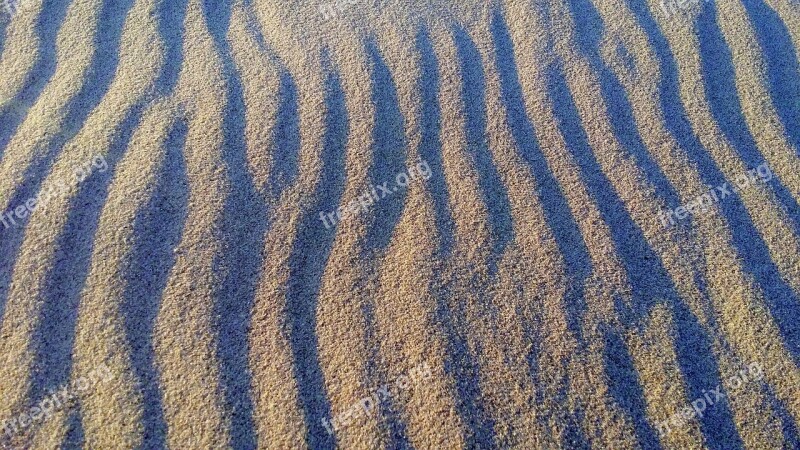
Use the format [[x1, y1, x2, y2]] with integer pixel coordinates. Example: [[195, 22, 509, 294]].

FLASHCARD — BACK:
[[548, 55, 741, 449]]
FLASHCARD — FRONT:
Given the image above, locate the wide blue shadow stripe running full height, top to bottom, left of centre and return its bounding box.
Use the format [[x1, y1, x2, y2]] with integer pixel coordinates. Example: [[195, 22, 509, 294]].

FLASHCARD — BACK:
[[203, 1, 260, 448]]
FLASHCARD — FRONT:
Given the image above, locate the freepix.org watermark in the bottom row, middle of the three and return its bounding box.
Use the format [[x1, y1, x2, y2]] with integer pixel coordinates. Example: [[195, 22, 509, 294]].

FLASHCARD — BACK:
[[322, 362, 431, 435]]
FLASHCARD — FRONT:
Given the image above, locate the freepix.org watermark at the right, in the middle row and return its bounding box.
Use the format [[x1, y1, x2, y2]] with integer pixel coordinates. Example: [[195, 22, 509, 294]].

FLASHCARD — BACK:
[[658, 163, 774, 227]]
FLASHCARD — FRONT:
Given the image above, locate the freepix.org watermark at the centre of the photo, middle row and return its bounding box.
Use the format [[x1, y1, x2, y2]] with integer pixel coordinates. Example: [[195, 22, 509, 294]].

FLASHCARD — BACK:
[[319, 161, 433, 230]]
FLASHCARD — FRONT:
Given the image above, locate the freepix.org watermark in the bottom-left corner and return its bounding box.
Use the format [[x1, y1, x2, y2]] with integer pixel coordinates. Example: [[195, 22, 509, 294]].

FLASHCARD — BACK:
[[0, 364, 114, 442]]
